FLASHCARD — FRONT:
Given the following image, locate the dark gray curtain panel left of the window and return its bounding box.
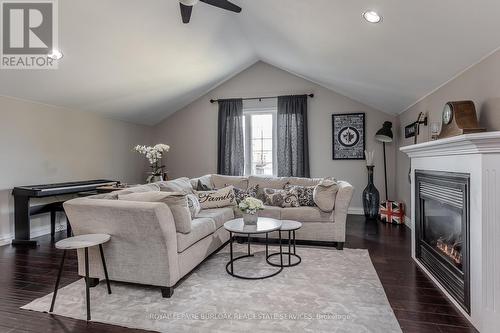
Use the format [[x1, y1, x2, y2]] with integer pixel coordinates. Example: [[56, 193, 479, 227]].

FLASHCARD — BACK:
[[217, 99, 245, 176]]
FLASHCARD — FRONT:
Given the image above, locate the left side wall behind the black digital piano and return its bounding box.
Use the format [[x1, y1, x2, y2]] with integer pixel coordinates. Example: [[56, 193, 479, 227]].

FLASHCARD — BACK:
[[0, 97, 150, 245]]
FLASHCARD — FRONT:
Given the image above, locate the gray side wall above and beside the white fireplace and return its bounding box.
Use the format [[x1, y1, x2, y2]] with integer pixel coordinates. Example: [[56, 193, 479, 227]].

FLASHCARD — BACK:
[[396, 51, 500, 216]]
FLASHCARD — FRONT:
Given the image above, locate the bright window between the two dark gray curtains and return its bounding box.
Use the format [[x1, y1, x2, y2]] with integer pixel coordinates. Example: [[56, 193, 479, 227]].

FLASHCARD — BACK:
[[243, 108, 277, 176]]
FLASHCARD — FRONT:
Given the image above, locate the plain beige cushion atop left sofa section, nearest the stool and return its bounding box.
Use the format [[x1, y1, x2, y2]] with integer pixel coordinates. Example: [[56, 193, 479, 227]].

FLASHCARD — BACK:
[[118, 192, 191, 234]]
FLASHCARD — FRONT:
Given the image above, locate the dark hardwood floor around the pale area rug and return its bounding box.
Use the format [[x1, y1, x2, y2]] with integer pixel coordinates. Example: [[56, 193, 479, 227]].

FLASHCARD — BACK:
[[0, 216, 476, 333]]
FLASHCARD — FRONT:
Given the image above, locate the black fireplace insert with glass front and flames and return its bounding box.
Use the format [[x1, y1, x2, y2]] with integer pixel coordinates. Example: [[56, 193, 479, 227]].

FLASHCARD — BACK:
[[415, 170, 470, 313]]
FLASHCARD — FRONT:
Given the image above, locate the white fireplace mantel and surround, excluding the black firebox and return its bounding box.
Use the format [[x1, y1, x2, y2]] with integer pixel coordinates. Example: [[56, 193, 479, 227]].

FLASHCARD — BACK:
[[400, 131, 500, 333]]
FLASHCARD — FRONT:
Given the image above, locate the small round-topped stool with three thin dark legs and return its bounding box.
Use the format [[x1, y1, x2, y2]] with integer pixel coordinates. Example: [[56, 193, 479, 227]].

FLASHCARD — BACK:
[[49, 234, 111, 321]]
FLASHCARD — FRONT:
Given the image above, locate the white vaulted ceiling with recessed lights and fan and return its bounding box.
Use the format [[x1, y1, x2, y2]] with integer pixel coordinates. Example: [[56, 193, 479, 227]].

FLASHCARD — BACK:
[[0, 0, 500, 124]]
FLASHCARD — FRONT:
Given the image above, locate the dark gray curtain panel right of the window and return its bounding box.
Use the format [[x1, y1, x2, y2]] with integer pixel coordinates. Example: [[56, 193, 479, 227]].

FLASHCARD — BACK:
[[277, 95, 309, 177]]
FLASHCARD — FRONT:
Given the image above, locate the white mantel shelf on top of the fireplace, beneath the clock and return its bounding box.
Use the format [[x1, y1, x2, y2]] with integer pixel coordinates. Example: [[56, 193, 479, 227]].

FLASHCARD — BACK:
[[399, 131, 500, 158]]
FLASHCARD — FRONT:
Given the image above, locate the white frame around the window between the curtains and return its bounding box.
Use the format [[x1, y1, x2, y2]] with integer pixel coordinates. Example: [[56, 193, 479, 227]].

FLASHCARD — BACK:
[[243, 107, 278, 176]]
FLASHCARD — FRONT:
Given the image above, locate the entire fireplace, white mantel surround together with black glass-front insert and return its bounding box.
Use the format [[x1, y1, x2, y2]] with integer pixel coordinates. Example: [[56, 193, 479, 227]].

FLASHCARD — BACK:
[[400, 132, 500, 333]]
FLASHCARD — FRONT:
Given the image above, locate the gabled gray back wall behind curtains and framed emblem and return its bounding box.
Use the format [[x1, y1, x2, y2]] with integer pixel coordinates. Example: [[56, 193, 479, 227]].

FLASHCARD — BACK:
[[155, 62, 396, 209]]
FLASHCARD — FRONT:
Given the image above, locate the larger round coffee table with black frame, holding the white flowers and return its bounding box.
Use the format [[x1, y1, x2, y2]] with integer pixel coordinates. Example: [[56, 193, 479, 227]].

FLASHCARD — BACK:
[[224, 217, 283, 280]]
